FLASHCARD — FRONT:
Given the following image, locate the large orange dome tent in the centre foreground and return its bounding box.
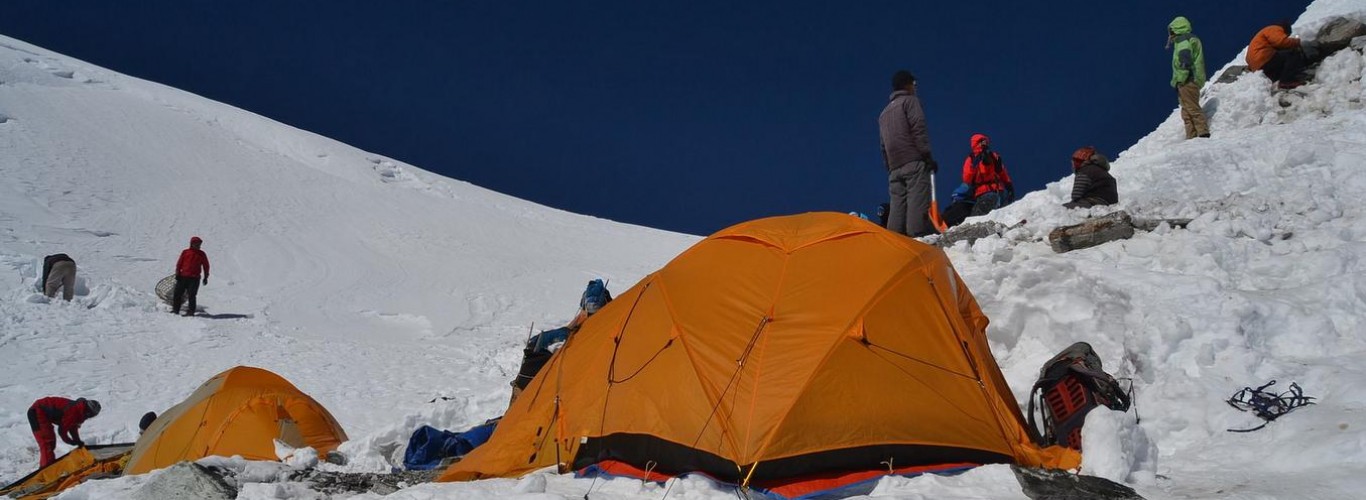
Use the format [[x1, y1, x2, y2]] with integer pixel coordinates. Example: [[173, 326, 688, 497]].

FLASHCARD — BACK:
[[440, 213, 1081, 482]]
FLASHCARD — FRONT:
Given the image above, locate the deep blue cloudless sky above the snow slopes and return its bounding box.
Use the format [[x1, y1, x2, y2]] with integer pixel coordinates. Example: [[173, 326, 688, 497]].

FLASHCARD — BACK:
[[0, 0, 1309, 235]]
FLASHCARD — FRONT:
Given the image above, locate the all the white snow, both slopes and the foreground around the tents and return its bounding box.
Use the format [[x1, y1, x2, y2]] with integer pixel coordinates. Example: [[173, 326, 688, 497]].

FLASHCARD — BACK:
[[0, 0, 1366, 499]]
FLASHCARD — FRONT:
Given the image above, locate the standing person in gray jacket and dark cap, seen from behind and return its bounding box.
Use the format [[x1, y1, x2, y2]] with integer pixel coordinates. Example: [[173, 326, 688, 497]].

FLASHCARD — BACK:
[[877, 70, 938, 236]]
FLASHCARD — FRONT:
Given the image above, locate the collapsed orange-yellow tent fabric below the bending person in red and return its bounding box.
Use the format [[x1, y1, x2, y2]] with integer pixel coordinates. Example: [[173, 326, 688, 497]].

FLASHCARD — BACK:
[[0, 443, 133, 500]]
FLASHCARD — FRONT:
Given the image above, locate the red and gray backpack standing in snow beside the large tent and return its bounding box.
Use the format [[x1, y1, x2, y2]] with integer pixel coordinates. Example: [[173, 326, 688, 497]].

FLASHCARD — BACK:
[[1029, 342, 1130, 449]]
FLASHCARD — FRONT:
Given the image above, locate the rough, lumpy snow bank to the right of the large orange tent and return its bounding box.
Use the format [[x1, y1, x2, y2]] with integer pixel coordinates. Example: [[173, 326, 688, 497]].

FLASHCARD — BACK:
[[949, 0, 1366, 499]]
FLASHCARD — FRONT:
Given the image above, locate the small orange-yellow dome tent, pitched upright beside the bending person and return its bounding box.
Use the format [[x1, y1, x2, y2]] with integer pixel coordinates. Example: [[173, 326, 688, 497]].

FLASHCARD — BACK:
[[127, 366, 347, 474]]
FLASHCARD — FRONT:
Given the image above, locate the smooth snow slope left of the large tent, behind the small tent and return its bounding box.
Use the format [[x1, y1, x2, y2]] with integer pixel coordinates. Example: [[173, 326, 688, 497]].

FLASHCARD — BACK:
[[0, 38, 697, 482]]
